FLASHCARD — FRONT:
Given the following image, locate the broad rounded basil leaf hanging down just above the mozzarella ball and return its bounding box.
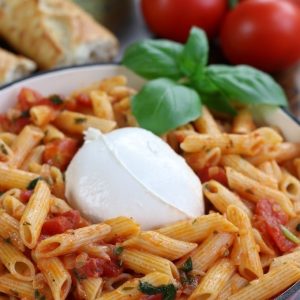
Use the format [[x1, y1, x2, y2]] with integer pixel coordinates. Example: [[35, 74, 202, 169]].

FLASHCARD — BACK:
[[132, 78, 201, 134]]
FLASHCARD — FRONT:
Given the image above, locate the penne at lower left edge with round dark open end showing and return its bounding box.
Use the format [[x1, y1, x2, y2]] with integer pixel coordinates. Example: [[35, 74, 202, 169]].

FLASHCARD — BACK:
[[0, 239, 35, 281]]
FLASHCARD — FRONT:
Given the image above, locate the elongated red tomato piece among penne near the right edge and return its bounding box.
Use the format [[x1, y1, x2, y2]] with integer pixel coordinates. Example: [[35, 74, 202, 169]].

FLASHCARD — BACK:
[[255, 199, 296, 252]]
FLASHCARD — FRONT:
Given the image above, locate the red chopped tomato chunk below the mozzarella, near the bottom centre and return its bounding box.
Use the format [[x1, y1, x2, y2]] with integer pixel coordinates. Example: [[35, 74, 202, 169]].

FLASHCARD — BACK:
[[76, 258, 122, 278]]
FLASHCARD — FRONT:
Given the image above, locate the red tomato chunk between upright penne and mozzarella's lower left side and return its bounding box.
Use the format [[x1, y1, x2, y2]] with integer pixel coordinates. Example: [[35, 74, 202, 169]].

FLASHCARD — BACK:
[[42, 210, 80, 235]]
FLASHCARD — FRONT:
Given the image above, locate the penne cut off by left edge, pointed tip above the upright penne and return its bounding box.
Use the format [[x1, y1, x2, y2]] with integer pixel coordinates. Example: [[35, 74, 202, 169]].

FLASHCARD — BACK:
[[0, 164, 39, 190]]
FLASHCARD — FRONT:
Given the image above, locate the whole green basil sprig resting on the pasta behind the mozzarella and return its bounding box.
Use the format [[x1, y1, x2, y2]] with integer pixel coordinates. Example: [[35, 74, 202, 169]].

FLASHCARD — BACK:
[[122, 27, 287, 134]]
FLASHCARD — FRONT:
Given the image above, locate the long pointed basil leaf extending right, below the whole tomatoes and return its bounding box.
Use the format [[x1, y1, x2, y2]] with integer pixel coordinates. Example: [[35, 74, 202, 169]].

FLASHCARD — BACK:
[[205, 65, 287, 106]]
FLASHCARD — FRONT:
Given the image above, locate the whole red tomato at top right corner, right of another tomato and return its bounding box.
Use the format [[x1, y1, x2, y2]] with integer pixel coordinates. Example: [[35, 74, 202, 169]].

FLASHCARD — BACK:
[[221, 0, 300, 72]]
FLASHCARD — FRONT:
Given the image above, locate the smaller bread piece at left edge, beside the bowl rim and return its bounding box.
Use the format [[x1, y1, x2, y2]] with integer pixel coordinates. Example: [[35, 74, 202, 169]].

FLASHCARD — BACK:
[[0, 48, 36, 85]]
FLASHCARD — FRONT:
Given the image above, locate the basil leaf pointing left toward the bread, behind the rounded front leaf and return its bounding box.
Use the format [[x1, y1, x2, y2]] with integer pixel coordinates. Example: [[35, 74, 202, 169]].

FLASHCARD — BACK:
[[122, 40, 183, 79]]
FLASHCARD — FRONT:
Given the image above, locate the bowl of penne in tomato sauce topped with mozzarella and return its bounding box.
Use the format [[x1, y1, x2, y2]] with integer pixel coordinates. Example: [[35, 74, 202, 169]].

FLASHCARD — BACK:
[[0, 61, 300, 300]]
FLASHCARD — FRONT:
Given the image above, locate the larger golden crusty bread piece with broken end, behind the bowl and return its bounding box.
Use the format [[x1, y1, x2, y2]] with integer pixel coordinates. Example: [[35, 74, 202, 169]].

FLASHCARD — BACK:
[[0, 0, 118, 69]]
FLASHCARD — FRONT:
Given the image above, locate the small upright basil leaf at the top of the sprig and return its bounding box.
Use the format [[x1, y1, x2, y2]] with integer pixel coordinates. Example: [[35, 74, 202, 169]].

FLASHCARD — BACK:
[[179, 27, 208, 77]]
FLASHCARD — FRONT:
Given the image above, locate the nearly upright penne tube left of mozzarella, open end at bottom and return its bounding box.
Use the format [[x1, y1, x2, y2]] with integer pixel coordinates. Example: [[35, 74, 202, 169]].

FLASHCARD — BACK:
[[20, 180, 51, 249]]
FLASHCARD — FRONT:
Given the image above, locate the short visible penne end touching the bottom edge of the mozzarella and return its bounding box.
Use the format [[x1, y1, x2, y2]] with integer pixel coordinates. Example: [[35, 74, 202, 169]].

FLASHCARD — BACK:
[[104, 217, 141, 242]]
